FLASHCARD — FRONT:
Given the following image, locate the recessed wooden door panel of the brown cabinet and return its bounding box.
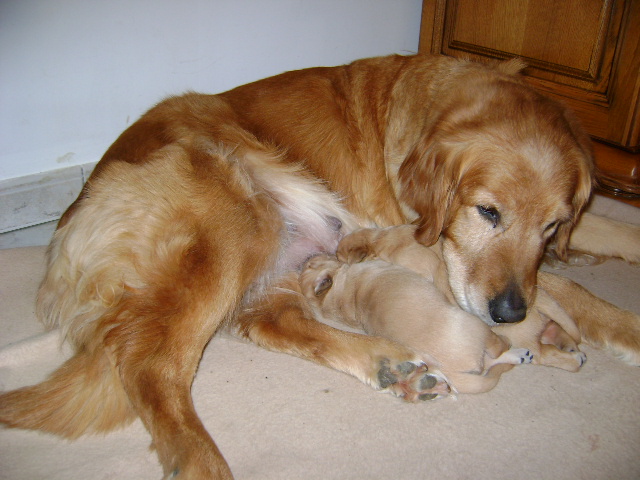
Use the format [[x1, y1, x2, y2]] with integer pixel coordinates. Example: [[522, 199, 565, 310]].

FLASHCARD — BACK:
[[445, 0, 608, 80]]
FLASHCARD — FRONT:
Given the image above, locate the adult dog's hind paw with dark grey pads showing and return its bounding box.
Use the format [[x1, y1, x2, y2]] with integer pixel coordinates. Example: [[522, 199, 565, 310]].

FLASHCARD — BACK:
[[377, 358, 451, 402]]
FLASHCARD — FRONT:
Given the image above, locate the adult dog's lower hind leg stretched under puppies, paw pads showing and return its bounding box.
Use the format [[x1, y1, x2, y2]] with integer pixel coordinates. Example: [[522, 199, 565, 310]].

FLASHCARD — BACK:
[[237, 274, 449, 402]]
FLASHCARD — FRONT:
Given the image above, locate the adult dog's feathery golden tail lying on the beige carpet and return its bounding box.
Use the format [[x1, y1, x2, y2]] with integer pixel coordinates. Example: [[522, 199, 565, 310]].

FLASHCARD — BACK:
[[0, 349, 135, 439]]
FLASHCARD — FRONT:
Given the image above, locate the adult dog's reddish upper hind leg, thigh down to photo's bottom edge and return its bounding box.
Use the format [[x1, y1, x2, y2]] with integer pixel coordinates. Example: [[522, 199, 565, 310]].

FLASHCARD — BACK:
[[94, 157, 282, 479]]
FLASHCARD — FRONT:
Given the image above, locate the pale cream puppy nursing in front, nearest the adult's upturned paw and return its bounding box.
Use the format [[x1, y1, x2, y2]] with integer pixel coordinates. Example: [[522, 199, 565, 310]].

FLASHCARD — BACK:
[[300, 253, 535, 400]]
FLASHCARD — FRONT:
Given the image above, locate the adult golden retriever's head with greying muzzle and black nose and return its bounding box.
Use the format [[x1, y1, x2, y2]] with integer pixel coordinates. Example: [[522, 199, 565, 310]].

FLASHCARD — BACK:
[[399, 63, 593, 325]]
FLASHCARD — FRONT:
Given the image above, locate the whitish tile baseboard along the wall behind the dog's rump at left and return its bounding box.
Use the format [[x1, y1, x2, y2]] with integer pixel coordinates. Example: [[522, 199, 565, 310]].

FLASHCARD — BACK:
[[0, 163, 95, 239]]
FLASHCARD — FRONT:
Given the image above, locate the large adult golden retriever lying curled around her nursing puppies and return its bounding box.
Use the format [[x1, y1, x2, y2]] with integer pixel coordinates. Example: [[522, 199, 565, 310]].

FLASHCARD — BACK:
[[0, 56, 640, 478]]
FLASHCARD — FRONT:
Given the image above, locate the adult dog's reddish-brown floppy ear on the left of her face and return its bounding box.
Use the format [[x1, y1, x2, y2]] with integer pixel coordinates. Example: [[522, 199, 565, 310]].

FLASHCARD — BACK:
[[398, 129, 458, 246]]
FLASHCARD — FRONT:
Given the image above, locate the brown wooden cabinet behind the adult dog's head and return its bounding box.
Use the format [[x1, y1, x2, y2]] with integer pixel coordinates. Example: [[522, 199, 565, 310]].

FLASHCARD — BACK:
[[420, 0, 640, 197]]
